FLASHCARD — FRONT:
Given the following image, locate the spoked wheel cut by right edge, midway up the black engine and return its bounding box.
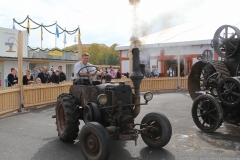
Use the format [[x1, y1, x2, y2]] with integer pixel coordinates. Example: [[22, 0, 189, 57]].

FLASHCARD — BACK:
[[218, 77, 240, 107]]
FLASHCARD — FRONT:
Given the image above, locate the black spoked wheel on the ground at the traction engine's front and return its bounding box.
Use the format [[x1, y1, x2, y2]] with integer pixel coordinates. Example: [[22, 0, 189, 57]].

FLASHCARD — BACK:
[[192, 94, 223, 132]]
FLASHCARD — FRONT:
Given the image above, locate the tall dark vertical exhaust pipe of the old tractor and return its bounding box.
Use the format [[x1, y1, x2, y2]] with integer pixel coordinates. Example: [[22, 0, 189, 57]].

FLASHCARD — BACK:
[[130, 48, 145, 118]]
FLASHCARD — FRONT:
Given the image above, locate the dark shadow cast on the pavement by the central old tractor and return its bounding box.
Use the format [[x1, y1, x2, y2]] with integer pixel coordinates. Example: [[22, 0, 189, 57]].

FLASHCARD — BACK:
[[32, 137, 175, 160]]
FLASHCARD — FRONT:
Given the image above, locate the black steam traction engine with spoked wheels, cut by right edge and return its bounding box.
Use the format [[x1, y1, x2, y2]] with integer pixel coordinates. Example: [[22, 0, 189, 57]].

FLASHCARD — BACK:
[[188, 25, 240, 132]]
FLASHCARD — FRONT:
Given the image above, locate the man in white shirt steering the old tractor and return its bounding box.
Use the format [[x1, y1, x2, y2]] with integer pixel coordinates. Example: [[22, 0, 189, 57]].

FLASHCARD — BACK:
[[74, 53, 104, 85]]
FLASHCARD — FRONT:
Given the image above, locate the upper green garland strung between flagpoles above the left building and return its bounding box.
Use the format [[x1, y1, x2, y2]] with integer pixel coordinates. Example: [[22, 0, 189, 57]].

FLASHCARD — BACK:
[[13, 16, 80, 37]]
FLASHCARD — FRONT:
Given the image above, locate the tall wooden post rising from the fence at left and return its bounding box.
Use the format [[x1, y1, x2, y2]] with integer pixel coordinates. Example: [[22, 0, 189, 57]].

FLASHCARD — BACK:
[[18, 31, 23, 110]]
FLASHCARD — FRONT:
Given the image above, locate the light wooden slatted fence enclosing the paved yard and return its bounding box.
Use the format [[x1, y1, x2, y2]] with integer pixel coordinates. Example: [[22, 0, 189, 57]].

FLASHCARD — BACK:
[[0, 77, 187, 116]]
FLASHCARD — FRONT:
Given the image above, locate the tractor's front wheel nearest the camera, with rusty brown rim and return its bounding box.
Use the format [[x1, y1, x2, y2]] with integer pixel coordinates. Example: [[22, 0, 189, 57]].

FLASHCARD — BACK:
[[80, 122, 111, 160]]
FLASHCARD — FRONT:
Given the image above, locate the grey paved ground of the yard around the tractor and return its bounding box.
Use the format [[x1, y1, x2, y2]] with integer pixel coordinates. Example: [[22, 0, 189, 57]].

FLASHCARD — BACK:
[[0, 92, 240, 160]]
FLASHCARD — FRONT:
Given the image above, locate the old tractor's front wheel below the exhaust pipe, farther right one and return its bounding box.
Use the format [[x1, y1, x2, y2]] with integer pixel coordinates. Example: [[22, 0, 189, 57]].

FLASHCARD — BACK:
[[140, 113, 172, 148]]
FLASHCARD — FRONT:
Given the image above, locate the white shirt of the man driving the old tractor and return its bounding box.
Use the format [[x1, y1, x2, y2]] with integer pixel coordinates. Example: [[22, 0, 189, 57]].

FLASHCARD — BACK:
[[74, 61, 96, 79]]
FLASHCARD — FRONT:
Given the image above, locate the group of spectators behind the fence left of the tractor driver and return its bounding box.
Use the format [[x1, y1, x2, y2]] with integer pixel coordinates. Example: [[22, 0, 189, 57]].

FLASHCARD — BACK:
[[7, 66, 67, 87]]
